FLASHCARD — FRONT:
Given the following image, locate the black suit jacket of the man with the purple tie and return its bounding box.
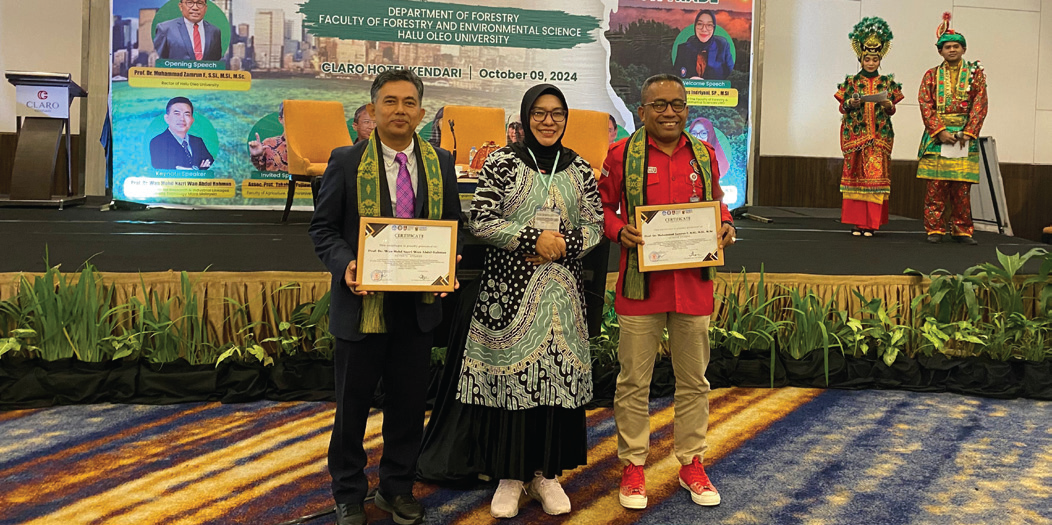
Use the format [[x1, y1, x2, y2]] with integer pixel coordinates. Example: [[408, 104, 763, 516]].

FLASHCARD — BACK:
[[309, 137, 461, 341]]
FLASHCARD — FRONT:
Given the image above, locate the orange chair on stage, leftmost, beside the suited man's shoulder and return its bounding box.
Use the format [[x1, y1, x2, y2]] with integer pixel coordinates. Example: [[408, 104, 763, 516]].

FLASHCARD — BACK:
[[281, 100, 353, 222]]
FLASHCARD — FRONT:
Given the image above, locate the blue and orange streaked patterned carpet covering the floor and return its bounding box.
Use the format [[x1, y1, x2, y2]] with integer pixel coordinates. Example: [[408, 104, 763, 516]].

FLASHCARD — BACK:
[[0, 388, 1052, 525]]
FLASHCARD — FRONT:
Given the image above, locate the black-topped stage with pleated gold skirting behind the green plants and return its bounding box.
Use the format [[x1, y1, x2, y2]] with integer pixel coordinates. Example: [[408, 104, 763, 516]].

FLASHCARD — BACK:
[[0, 197, 1048, 357]]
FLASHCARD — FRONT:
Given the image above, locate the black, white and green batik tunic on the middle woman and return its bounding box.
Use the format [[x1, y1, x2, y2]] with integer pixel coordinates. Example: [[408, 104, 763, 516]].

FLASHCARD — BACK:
[[458, 147, 603, 410]]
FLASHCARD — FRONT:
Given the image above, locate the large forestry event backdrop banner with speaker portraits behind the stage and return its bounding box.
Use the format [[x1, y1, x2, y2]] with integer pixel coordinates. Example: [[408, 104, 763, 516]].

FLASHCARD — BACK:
[[110, 0, 752, 207]]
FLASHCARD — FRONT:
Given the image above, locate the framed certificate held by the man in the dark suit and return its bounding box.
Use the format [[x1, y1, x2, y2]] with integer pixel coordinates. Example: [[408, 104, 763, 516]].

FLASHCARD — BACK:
[[356, 217, 457, 291]]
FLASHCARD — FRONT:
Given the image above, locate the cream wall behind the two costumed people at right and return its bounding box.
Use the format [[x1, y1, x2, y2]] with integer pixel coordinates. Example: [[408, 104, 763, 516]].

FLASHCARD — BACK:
[[760, 0, 1052, 164]]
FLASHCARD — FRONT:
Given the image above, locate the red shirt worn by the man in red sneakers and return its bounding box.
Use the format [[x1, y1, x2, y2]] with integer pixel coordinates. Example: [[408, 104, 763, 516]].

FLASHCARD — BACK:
[[599, 136, 731, 316]]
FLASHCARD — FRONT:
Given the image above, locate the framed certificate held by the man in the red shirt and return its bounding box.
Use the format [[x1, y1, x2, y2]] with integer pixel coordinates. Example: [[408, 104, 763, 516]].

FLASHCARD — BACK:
[[635, 201, 724, 271]]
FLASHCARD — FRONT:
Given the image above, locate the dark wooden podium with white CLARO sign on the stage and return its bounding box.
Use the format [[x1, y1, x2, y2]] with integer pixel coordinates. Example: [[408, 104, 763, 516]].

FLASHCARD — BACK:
[[0, 72, 87, 209]]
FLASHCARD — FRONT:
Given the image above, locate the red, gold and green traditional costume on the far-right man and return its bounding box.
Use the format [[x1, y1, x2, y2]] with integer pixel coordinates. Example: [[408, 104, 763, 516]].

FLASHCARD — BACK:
[[917, 60, 988, 236]]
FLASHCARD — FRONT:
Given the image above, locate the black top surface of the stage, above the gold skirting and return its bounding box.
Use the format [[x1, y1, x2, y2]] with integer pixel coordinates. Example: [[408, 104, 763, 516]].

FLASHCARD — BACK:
[[0, 199, 1049, 276]]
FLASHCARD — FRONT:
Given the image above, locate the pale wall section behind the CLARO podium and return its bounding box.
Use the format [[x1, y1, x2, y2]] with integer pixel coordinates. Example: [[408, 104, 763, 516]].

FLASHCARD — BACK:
[[0, 0, 84, 133]]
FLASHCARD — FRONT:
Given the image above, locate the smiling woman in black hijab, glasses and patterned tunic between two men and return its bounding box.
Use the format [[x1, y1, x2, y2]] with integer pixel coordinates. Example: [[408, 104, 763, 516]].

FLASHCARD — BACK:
[[457, 84, 603, 518]]
